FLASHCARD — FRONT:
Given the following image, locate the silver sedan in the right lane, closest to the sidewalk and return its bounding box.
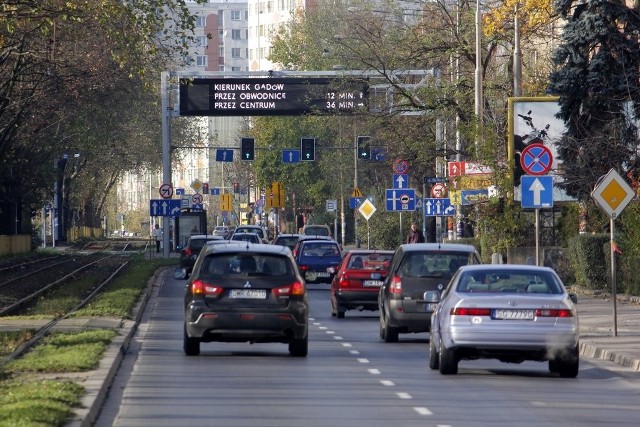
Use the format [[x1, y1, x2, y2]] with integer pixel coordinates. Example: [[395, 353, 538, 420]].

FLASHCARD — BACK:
[[425, 264, 579, 378]]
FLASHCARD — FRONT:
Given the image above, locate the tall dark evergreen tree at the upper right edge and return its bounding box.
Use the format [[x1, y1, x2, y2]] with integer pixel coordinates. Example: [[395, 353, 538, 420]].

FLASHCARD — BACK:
[[549, 0, 640, 200]]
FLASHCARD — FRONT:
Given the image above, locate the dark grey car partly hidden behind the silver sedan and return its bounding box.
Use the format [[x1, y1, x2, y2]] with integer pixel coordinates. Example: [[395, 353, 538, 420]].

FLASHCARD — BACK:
[[378, 243, 480, 342]]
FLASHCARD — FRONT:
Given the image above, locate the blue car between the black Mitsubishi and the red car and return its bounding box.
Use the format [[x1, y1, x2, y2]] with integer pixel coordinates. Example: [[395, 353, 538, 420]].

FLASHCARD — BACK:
[[293, 237, 342, 283]]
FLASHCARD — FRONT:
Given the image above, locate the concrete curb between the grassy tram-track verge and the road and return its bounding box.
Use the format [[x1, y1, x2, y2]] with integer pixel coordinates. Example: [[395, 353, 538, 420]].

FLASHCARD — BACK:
[[65, 267, 172, 427]]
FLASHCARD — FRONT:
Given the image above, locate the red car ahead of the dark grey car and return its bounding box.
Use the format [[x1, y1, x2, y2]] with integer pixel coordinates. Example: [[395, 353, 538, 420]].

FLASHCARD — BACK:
[[329, 249, 393, 319]]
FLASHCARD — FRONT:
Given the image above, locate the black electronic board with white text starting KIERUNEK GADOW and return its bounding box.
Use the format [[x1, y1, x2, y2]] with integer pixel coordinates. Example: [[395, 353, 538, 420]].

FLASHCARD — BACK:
[[180, 77, 369, 116]]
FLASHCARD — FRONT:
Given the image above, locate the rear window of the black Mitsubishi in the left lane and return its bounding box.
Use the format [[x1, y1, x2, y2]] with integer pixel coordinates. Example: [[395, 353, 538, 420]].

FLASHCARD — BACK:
[[200, 253, 295, 279]]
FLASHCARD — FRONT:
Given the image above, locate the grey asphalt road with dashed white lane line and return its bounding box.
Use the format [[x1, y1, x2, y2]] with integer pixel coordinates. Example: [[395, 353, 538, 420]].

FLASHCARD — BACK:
[[95, 274, 640, 427]]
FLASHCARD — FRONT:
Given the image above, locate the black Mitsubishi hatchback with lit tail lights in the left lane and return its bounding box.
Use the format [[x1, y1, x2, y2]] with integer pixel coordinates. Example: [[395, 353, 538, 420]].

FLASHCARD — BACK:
[[183, 242, 309, 357]]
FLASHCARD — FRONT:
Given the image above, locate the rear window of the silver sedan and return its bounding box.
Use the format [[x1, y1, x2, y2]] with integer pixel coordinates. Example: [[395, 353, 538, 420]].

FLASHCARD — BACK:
[[456, 270, 562, 294]]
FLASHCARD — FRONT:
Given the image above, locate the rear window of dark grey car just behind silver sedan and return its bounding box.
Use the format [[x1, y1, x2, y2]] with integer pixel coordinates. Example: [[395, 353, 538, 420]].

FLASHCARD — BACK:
[[399, 251, 470, 278]]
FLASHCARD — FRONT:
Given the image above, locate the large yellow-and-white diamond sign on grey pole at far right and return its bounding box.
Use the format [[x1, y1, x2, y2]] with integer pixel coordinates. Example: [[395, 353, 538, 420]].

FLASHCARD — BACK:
[[591, 169, 635, 337]]
